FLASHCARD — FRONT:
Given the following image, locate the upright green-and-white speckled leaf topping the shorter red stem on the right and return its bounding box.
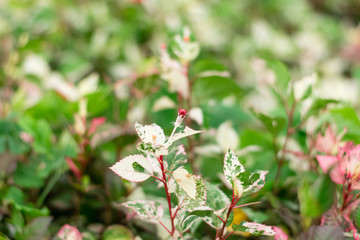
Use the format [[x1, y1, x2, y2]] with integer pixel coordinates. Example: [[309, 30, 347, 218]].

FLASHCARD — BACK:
[[224, 148, 245, 185]]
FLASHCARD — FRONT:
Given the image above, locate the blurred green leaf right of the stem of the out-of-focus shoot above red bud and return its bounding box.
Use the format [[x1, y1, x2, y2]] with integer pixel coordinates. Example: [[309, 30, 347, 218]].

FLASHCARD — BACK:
[[192, 76, 244, 102]]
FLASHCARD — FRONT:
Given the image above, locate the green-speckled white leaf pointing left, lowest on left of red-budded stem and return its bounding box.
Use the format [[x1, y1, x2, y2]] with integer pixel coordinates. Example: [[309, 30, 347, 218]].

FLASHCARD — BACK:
[[121, 200, 164, 221]]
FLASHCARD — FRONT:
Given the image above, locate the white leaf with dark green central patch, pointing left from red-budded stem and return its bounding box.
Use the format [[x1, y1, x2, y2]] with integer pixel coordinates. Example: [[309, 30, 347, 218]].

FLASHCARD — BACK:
[[110, 154, 153, 182]]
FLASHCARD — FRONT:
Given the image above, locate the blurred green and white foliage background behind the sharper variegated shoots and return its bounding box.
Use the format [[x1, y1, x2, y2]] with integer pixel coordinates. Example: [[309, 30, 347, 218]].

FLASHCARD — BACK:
[[0, 0, 360, 239]]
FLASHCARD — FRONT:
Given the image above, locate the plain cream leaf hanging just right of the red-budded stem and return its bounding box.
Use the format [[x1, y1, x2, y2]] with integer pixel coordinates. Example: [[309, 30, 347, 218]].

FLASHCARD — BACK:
[[173, 167, 196, 199]]
